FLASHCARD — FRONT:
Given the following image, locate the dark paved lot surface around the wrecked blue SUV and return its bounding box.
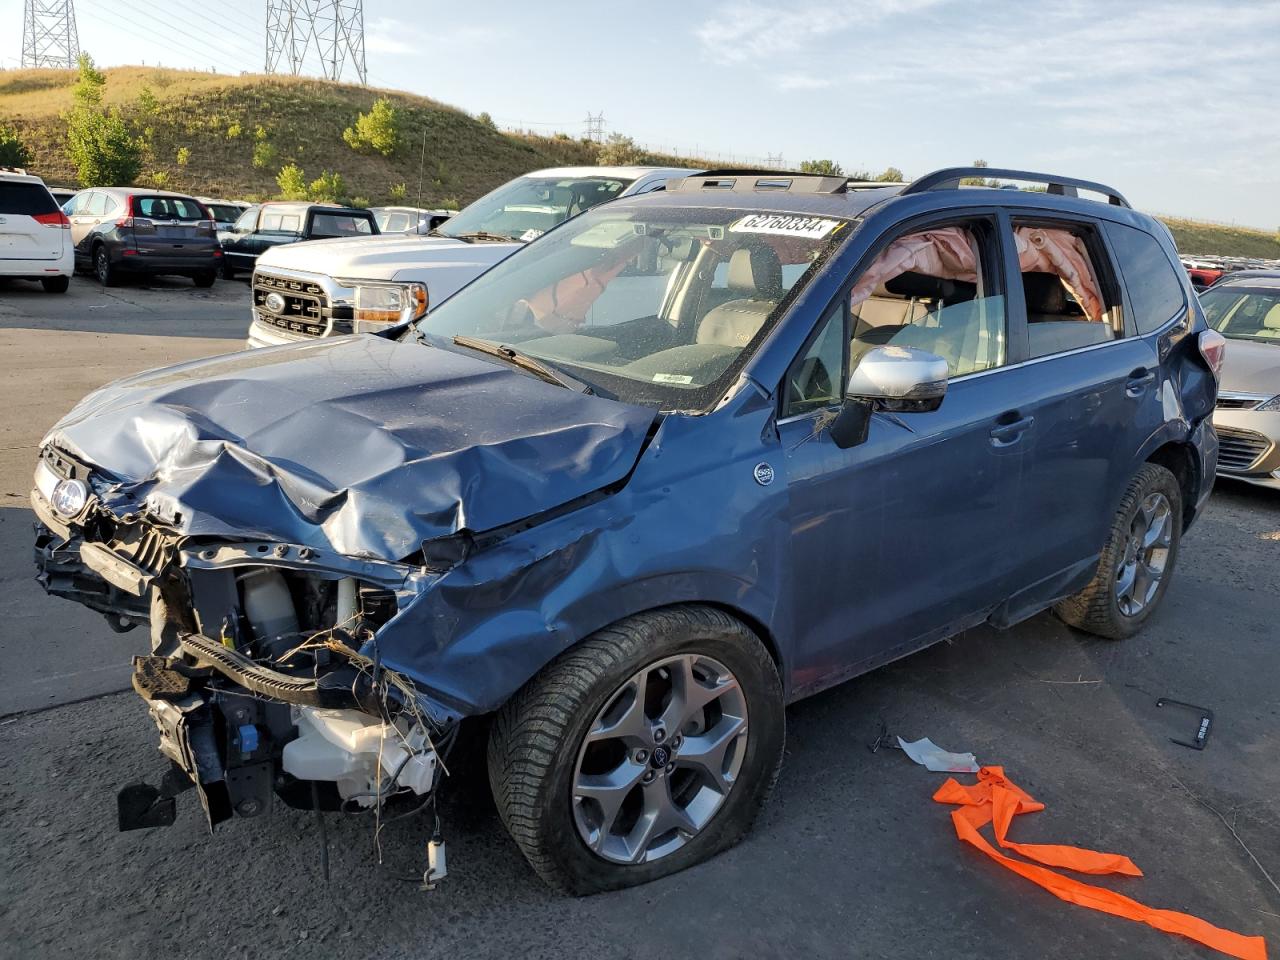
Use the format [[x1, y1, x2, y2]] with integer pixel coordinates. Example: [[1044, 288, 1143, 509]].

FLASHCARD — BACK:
[[0, 273, 1280, 960]]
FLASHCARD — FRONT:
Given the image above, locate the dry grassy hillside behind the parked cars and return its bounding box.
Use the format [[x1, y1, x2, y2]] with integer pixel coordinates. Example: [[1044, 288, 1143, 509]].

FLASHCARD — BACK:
[[0, 67, 1280, 259]]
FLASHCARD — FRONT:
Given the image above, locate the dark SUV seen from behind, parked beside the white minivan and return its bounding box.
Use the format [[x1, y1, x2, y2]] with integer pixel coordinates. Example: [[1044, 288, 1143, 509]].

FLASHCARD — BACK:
[[63, 187, 223, 287]]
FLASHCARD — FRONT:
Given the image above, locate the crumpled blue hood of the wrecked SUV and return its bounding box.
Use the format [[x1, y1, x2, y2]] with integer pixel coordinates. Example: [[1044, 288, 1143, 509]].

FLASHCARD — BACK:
[[45, 335, 655, 559]]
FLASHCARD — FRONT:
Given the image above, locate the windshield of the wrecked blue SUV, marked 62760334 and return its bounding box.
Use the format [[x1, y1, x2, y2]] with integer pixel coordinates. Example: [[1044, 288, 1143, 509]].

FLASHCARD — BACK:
[[419, 205, 849, 410]]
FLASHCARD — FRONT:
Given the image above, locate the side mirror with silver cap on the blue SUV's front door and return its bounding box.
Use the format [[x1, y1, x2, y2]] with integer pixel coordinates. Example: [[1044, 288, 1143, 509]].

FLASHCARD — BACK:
[[831, 344, 947, 449]]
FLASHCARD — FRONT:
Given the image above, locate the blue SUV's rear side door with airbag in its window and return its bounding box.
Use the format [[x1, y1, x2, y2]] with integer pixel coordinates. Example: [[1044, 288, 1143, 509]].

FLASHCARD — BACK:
[[988, 210, 1164, 601]]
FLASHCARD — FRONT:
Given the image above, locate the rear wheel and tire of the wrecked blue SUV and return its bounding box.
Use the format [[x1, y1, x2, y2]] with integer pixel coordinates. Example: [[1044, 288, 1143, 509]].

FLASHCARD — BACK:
[[1053, 463, 1183, 640]]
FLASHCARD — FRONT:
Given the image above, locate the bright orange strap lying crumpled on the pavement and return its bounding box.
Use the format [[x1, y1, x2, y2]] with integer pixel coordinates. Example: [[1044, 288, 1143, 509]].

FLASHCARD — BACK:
[[933, 767, 1267, 960]]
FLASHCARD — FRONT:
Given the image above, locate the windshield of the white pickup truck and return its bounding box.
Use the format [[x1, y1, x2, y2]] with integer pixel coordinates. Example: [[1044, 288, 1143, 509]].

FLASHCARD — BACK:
[[440, 177, 631, 241]]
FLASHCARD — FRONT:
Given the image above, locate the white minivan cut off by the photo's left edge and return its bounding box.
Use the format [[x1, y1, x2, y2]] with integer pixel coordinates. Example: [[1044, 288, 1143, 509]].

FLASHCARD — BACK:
[[0, 169, 76, 293]]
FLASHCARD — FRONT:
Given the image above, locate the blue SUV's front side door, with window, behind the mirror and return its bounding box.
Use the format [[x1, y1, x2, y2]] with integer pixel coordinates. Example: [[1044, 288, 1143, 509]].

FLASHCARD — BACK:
[[778, 218, 1033, 694]]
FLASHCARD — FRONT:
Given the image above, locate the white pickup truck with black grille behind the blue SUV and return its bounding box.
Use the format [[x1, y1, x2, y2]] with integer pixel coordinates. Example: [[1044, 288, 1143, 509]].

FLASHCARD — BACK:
[[247, 166, 696, 347]]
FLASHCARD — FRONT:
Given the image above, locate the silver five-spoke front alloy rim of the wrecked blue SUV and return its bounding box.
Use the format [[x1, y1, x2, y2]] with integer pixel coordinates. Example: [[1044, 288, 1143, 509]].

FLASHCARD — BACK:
[[572, 654, 748, 864]]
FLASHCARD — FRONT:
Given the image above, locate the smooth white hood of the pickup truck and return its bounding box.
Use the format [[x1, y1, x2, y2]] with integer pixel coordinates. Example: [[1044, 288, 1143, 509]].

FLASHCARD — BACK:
[[257, 236, 524, 280]]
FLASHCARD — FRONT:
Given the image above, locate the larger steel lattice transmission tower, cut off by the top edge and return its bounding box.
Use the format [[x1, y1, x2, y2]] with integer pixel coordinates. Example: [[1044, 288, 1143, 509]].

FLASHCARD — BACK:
[[266, 0, 369, 83]]
